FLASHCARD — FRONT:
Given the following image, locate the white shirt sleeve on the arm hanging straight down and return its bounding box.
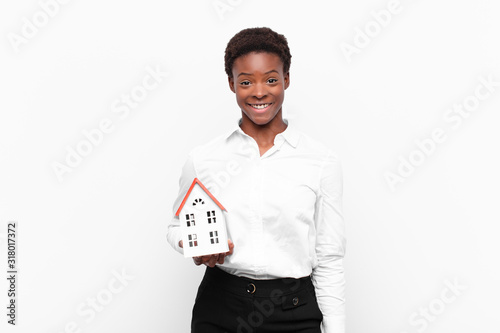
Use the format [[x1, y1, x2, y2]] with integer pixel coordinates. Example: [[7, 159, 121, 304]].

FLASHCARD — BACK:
[[312, 151, 346, 333]]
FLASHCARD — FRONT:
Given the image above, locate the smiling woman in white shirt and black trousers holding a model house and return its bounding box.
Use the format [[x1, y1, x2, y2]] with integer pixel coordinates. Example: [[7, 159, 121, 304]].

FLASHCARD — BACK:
[[168, 28, 346, 333]]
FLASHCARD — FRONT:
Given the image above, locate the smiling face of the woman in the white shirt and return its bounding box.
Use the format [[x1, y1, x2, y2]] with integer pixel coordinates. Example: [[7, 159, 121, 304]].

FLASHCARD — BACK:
[[229, 52, 290, 125]]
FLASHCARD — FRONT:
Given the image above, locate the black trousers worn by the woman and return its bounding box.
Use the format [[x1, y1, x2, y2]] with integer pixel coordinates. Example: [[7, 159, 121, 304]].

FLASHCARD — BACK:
[[191, 266, 323, 333]]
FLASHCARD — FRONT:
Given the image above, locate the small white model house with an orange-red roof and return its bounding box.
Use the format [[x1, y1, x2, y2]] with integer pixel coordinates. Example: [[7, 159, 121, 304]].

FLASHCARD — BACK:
[[175, 178, 229, 258]]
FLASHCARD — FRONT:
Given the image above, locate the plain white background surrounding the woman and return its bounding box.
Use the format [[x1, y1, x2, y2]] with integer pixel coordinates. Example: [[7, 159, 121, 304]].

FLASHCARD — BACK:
[[0, 0, 500, 333]]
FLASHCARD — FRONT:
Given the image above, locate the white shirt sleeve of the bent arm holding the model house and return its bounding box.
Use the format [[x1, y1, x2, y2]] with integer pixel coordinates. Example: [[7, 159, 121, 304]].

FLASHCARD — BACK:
[[167, 151, 196, 254]]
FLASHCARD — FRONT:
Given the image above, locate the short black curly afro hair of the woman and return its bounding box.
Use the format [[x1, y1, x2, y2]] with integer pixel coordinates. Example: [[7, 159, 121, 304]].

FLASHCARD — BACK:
[[224, 27, 292, 78]]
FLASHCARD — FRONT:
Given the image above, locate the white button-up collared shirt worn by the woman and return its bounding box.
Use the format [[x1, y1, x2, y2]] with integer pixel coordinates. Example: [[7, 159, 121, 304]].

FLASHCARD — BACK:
[[167, 118, 346, 333]]
